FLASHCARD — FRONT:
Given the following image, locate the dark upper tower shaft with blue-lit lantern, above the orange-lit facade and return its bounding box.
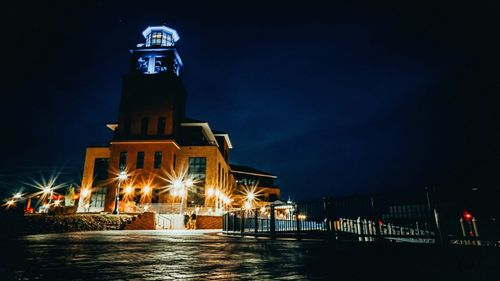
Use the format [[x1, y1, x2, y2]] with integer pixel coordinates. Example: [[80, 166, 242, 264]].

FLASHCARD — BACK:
[[113, 26, 186, 141]]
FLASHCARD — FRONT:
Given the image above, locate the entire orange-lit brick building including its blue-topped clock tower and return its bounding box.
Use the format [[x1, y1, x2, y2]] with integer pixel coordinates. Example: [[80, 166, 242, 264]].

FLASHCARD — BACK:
[[79, 26, 279, 212]]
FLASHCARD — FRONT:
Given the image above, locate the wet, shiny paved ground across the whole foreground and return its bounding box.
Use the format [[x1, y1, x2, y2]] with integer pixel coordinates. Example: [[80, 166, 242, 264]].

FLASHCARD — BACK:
[[0, 231, 500, 281]]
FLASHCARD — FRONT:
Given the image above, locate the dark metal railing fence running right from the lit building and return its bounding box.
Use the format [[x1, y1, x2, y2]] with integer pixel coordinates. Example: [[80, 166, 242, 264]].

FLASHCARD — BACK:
[[223, 191, 500, 246]]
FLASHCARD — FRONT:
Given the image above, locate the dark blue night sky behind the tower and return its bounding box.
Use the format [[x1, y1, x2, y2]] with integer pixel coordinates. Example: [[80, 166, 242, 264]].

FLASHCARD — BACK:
[[0, 1, 500, 199]]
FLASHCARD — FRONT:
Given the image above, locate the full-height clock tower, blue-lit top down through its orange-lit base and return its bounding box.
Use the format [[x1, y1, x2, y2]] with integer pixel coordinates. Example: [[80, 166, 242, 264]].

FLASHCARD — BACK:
[[105, 26, 186, 210]]
